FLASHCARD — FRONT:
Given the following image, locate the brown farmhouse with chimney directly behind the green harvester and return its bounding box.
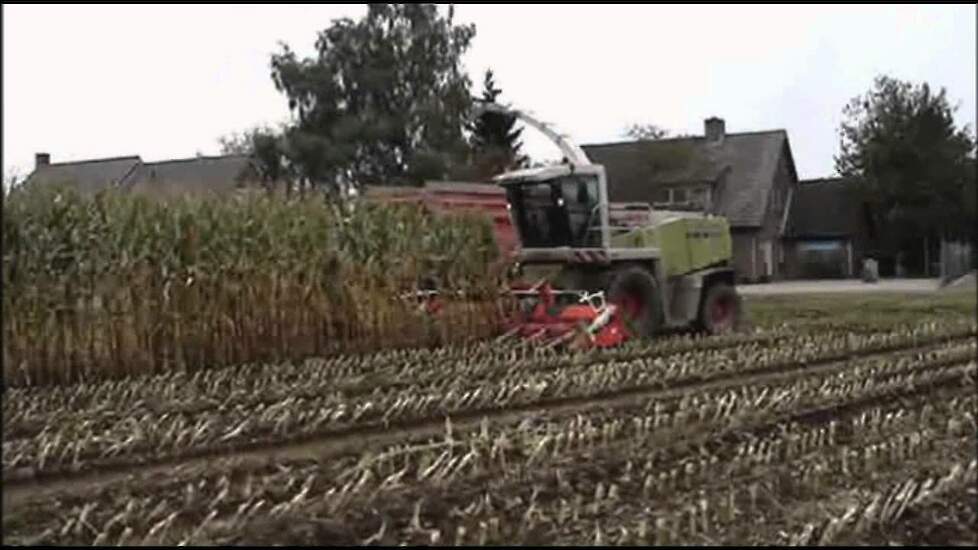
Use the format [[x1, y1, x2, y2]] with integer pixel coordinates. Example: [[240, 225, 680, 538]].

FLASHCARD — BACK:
[[583, 118, 798, 281]]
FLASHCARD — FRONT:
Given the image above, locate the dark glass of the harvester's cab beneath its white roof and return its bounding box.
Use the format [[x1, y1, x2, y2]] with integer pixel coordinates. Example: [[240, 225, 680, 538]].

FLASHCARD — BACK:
[[506, 175, 601, 248]]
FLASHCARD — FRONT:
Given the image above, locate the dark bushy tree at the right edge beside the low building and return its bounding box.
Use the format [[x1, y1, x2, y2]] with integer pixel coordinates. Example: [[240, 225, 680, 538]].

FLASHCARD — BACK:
[[835, 76, 975, 266]]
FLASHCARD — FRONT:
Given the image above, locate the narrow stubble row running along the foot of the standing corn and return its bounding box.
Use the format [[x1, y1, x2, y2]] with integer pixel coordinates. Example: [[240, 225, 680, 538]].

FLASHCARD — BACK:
[[3, 321, 978, 426]]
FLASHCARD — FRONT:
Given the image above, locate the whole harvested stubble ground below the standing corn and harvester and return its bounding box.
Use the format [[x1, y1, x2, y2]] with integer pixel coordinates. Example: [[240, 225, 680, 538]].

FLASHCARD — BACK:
[[3, 293, 978, 545]]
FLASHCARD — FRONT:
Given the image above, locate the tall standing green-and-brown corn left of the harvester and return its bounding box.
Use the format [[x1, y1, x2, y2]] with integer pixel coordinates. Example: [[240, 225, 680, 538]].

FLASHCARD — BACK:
[[3, 185, 497, 386]]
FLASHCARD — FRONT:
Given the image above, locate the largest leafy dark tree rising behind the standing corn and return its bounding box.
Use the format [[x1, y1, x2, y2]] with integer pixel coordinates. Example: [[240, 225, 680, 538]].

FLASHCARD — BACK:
[[272, 4, 475, 190]]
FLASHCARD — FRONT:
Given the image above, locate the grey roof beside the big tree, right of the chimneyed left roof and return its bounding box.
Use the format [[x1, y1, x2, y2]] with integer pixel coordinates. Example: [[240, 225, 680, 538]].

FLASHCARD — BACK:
[[123, 155, 252, 197]]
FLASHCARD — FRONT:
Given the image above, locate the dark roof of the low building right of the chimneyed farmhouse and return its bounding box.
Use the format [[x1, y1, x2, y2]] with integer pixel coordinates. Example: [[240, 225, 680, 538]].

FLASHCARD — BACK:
[[787, 178, 861, 238]]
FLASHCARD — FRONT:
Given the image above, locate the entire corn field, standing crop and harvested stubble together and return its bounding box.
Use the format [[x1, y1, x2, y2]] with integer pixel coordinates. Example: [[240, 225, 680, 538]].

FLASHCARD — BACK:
[[2, 187, 978, 546]]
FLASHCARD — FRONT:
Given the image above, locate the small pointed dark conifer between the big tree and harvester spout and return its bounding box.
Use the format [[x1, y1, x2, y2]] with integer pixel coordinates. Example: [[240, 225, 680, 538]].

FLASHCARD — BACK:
[[470, 69, 528, 177]]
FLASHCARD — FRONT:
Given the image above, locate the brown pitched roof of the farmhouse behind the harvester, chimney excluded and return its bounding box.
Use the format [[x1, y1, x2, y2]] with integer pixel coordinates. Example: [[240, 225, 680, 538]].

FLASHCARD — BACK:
[[583, 130, 793, 227]]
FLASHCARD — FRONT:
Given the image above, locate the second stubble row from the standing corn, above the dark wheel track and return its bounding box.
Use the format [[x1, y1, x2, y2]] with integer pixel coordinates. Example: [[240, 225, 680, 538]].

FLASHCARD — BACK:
[[3, 324, 975, 475]]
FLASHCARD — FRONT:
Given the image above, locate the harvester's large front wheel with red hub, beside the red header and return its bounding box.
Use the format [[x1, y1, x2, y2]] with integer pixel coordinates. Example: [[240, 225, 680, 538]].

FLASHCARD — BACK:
[[607, 267, 663, 338]]
